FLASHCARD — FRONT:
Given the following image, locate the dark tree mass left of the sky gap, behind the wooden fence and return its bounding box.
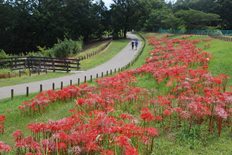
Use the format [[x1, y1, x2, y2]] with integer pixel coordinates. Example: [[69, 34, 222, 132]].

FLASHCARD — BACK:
[[0, 0, 109, 54]]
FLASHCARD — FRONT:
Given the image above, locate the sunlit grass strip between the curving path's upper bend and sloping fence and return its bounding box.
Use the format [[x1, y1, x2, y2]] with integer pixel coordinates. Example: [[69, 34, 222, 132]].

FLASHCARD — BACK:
[[81, 39, 129, 70]]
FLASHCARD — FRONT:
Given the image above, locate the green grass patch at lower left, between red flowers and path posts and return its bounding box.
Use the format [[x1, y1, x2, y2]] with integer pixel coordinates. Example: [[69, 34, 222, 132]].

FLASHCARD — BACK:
[[0, 94, 74, 146]]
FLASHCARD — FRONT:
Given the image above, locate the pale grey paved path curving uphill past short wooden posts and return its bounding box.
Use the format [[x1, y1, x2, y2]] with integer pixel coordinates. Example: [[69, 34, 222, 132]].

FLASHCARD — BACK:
[[0, 33, 142, 100]]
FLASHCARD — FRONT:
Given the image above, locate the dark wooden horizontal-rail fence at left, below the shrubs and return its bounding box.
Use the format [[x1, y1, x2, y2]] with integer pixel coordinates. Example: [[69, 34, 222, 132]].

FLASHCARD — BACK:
[[0, 57, 80, 72]]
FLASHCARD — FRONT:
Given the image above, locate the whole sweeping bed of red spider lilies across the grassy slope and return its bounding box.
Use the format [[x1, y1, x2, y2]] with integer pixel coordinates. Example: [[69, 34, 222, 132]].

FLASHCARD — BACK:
[[1, 35, 232, 155]]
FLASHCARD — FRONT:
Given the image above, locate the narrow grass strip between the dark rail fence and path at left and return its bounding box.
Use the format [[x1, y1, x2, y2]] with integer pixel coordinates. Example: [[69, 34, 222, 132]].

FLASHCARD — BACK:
[[0, 72, 70, 87]]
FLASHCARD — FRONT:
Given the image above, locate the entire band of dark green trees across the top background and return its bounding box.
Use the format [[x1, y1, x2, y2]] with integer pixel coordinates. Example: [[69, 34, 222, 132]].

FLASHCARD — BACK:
[[0, 0, 232, 54]]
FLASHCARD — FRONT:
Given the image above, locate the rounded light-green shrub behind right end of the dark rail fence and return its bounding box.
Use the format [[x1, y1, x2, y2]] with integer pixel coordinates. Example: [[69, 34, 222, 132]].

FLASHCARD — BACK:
[[51, 39, 82, 58]]
